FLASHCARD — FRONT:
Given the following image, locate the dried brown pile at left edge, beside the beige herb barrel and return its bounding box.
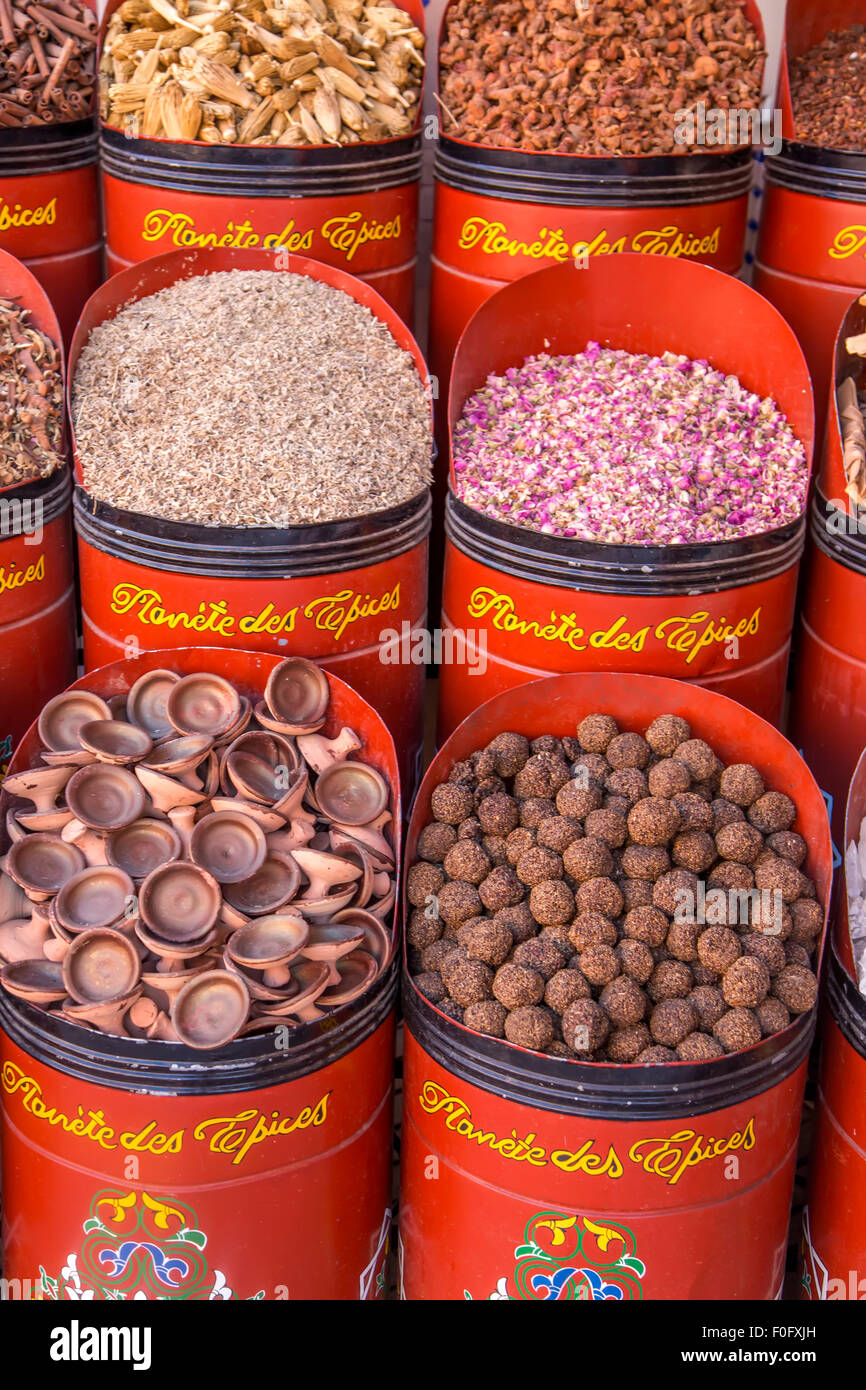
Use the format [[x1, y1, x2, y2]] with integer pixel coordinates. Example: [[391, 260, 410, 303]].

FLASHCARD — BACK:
[[0, 299, 65, 488]]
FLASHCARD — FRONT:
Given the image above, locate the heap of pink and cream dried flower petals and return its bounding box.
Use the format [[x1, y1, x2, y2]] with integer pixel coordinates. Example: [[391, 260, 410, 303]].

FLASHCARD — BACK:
[[453, 342, 809, 545]]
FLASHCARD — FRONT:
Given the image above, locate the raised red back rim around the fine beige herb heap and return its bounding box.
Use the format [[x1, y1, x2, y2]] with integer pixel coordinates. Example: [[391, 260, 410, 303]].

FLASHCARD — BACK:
[[67, 247, 432, 494]]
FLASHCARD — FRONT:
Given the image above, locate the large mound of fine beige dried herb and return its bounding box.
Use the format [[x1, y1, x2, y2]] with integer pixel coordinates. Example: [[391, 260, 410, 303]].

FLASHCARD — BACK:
[[72, 271, 431, 527]]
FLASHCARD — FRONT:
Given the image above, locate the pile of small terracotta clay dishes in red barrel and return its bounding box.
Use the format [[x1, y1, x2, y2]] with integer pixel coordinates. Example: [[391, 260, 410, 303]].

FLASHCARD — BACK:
[[0, 657, 395, 1048]]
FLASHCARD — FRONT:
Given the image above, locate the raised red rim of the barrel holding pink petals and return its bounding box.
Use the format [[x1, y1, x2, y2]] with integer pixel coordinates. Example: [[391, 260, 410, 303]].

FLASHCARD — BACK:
[[448, 252, 815, 559]]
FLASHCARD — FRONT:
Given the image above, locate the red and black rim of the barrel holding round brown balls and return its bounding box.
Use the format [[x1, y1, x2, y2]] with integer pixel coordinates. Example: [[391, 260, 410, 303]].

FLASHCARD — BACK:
[[400, 671, 833, 1118]]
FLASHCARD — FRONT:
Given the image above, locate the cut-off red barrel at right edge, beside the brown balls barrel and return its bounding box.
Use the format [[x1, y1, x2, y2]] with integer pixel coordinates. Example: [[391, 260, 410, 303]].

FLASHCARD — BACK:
[[801, 753, 866, 1302]]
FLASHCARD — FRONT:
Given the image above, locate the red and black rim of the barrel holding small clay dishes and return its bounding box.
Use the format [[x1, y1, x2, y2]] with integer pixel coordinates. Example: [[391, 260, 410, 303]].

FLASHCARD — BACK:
[[0, 646, 403, 1073]]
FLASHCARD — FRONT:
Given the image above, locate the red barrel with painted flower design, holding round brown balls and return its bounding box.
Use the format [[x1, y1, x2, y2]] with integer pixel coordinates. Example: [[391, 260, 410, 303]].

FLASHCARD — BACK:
[[400, 674, 831, 1300]]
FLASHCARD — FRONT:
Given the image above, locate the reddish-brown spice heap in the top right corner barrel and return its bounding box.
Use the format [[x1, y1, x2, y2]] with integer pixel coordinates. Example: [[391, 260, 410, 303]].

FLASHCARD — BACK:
[[790, 24, 866, 154]]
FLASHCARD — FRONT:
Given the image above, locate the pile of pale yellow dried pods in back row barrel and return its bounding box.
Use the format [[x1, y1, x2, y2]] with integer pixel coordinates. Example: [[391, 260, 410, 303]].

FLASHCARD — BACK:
[[100, 0, 424, 145]]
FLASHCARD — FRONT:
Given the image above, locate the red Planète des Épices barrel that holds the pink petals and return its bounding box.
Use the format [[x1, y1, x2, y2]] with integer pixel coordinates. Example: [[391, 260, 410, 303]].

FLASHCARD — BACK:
[[439, 256, 813, 735]]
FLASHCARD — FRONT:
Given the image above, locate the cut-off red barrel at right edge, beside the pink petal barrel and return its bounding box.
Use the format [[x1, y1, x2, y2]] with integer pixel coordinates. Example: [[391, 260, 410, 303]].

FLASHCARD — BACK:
[[791, 287, 866, 835]]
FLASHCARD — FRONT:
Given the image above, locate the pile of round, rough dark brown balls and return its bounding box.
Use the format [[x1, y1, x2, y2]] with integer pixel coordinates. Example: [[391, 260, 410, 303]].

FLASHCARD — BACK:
[[406, 714, 823, 1063]]
